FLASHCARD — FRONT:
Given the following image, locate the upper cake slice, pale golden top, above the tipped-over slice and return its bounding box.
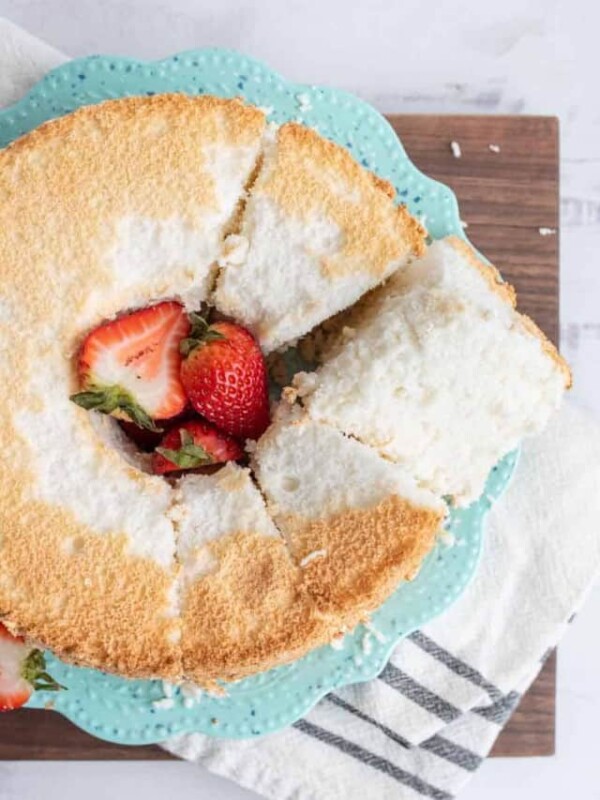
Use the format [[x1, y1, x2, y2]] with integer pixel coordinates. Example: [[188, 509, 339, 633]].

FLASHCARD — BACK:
[[214, 123, 424, 352]]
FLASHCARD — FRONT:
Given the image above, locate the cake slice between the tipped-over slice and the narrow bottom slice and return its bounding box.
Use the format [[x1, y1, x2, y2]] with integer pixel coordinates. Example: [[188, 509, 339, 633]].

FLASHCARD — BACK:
[[254, 410, 446, 628]]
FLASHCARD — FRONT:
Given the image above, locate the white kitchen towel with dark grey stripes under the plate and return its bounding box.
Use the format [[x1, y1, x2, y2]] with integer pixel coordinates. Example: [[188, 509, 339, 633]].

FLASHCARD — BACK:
[[0, 20, 600, 800]]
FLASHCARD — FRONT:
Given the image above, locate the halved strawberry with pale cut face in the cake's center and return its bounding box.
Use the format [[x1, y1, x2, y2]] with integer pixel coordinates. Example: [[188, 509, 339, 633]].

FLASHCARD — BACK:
[[71, 301, 190, 431]]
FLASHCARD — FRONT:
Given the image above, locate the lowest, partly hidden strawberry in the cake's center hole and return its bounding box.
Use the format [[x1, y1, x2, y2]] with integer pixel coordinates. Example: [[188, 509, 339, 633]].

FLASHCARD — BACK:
[[152, 420, 244, 475]]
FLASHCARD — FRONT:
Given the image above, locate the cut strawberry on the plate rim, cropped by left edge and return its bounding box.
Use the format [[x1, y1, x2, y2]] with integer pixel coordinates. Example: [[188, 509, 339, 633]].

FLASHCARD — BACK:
[[0, 622, 64, 711]]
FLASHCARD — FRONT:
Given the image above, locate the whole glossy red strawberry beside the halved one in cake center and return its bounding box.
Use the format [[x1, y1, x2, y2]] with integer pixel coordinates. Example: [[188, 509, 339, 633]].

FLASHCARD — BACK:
[[181, 314, 270, 439]]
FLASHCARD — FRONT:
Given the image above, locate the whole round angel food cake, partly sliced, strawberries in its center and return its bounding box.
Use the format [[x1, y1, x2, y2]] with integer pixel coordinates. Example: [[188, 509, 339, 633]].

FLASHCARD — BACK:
[[0, 95, 568, 685]]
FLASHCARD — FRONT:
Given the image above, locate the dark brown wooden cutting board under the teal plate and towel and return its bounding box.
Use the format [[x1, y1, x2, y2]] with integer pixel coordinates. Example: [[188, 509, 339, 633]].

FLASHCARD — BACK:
[[0, 115, 558, 760]]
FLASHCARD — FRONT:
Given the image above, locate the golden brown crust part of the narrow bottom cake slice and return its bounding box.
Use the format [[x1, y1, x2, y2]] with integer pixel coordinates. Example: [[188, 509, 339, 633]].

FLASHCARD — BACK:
[[182, 533, 340, 686]]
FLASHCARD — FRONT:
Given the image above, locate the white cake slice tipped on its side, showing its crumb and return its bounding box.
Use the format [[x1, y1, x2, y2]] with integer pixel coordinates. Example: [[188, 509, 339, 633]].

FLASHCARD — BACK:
[[296, 237, 571, 505]]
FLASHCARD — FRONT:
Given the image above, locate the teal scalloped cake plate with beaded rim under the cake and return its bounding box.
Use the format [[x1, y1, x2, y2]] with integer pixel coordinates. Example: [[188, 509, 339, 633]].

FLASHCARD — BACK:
[[0, 49, 516, 745]]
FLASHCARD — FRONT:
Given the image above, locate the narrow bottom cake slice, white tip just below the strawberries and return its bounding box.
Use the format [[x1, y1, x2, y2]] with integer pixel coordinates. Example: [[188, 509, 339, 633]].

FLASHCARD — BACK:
[[177, 463, 339, 686]]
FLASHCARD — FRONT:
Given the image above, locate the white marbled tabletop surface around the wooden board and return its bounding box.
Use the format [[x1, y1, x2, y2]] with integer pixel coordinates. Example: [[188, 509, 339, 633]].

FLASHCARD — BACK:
[[0, 0, 600, 800]]
